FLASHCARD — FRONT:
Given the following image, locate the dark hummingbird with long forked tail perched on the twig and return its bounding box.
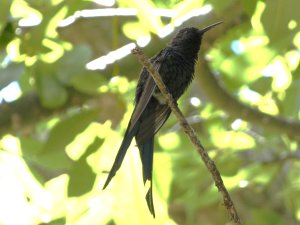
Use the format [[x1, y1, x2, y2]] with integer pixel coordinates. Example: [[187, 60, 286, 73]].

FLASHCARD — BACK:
[[103, 22, 222, 217]]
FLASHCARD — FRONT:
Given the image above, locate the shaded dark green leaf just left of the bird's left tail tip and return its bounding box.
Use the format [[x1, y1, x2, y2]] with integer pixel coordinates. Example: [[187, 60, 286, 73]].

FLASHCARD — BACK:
[[68, 137, 103, 197]]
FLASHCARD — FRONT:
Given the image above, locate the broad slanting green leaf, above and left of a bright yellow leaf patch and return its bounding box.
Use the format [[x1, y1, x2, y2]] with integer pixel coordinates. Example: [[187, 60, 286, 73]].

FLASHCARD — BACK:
[[40, 110, 99, 155]]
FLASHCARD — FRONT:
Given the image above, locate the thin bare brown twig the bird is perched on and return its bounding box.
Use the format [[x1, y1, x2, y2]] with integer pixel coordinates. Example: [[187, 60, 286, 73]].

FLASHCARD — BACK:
[[132, 48, 242, 225]]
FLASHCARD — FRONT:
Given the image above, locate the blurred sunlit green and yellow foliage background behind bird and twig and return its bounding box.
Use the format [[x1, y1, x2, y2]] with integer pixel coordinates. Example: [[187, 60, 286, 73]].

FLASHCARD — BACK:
[[0, 0, 300, 225]]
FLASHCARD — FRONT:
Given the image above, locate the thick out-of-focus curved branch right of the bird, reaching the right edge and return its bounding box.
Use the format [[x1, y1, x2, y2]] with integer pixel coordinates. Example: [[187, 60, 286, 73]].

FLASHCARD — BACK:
[[196, 62, 300, 140]]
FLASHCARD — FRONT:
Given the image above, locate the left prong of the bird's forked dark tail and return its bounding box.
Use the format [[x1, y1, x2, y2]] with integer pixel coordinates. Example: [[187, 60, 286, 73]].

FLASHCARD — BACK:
[[103, 123, 139, 189]]
